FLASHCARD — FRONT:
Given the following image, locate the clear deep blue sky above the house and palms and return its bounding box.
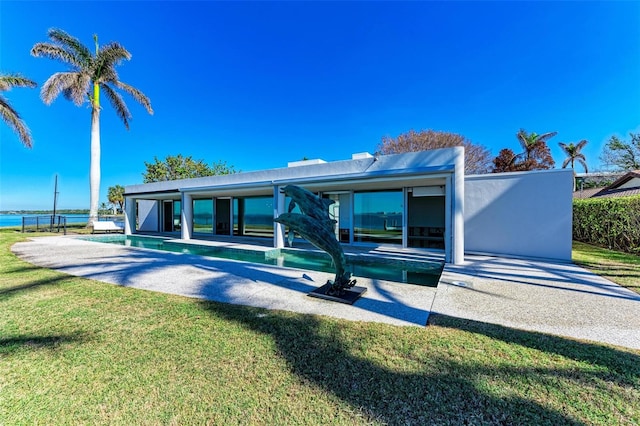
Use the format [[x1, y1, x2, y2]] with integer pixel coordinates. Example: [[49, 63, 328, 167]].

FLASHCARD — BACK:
[[0, 0, 640, 210]]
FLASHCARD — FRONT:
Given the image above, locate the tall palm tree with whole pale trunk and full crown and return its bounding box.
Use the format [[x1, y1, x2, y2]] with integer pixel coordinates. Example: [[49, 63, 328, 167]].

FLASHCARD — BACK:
[[31, 29, 153, 224]]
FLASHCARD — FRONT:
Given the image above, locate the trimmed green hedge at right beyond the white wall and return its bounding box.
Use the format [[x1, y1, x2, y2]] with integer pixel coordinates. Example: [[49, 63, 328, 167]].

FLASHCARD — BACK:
[[573, 196, 640, 253]]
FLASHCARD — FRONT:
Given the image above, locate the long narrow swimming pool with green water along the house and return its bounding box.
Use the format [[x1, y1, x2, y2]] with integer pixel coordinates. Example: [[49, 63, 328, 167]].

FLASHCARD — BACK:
[[80, 234, 444, 287]]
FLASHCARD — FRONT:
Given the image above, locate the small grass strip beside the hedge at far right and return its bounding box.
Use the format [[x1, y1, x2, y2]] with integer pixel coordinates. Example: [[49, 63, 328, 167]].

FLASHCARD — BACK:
[[572, 241, 640, 293]]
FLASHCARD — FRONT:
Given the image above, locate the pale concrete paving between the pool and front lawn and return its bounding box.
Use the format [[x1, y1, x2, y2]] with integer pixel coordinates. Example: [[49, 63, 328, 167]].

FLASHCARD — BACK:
[[12, 237, 640, 349]]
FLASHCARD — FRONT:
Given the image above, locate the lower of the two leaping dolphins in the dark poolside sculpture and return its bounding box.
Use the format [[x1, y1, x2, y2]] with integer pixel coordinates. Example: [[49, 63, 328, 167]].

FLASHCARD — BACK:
[[274, 213, 356, 295]]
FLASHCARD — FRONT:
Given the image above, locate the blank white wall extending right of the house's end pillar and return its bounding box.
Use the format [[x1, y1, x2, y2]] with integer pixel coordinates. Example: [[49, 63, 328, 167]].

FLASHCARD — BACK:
[[464, 169, 573, 261]]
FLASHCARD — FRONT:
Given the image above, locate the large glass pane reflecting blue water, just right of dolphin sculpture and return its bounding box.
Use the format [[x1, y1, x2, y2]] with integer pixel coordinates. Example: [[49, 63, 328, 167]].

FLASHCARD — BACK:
[[353, 189, 404, 244]]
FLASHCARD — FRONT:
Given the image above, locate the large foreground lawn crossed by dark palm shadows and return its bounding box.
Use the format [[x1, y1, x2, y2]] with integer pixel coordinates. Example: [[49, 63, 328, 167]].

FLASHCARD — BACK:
[[0, 232, 640, 425]]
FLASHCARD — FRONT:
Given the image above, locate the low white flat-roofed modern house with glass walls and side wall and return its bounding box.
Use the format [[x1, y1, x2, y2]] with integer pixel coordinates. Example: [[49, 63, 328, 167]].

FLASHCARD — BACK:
[[125, 147, 573, 264]]
